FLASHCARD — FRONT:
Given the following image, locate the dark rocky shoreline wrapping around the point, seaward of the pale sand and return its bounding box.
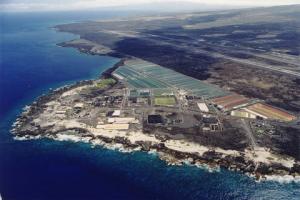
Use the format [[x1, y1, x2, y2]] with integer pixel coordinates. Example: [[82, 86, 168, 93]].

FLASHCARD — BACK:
[[11, 39, 300, 183]]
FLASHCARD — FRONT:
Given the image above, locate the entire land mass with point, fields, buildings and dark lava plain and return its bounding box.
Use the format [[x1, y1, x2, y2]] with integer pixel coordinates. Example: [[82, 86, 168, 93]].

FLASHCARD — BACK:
[[12, 6, 300, 179]]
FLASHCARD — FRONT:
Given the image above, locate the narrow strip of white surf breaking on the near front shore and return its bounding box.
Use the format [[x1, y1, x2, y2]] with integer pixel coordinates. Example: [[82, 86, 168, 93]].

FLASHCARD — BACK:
[[14, 131, 300, 184]]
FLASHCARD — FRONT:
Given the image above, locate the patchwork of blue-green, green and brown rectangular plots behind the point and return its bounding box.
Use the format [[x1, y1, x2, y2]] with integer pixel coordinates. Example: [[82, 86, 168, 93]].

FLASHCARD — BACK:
[[113, 59, 297, 135]]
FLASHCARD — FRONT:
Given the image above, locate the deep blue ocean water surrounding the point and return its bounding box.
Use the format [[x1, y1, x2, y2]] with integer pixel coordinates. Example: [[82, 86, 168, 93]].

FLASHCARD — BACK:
[[0, 12, 300, 200]]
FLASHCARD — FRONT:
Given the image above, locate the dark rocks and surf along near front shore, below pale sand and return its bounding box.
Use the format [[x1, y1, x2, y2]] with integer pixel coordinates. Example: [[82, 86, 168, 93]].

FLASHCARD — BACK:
[[15, 128, 300, 182]]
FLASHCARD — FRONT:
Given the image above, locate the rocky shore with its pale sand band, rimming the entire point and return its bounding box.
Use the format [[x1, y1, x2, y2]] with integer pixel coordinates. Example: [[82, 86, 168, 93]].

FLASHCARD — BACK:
[[11, 54, 300, 182]]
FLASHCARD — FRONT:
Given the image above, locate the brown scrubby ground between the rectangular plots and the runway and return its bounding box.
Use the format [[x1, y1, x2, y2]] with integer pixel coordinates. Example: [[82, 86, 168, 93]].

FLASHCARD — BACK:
[[207, 61, 300, 113]]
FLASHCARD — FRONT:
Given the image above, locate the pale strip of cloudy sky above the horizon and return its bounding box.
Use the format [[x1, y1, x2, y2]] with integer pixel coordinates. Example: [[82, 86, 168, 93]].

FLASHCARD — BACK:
[[0, 0, 300, 11]]
